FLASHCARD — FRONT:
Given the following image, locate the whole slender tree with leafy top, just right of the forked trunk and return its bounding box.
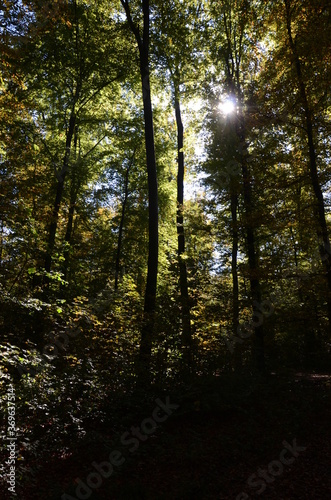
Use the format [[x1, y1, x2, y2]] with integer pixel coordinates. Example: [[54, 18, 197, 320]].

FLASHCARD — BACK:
[[155, 2, 203, 371]]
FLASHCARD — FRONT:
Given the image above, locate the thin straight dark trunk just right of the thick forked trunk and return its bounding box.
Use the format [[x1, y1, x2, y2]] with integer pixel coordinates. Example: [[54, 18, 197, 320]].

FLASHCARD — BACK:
[[175, 96, 192, 371]]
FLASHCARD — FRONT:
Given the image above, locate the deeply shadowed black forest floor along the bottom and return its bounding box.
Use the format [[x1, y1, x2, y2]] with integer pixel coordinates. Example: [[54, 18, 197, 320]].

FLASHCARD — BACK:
[[4, 373, 331, 500]]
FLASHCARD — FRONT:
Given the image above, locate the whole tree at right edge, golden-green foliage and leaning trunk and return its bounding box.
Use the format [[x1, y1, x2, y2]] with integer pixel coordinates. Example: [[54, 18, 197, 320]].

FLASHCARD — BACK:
[[260, 1, 330, 348]]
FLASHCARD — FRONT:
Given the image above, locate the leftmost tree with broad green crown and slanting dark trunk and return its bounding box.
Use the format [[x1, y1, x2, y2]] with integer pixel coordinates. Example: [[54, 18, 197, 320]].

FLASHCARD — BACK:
[[22, 0, 123, 273]]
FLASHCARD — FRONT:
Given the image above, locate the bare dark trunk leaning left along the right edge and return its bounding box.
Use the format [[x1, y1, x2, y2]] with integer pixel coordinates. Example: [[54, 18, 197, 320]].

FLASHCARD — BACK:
[[284, 0, 331, 333]]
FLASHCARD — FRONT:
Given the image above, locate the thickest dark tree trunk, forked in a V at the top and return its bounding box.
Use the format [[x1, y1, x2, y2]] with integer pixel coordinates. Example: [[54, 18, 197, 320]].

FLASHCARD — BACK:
[[121, 0, 159, 383]]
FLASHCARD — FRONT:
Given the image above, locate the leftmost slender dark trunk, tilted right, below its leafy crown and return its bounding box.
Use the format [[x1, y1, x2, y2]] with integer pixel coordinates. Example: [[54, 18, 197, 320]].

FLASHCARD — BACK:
[[45, 108, 76, 273]]
